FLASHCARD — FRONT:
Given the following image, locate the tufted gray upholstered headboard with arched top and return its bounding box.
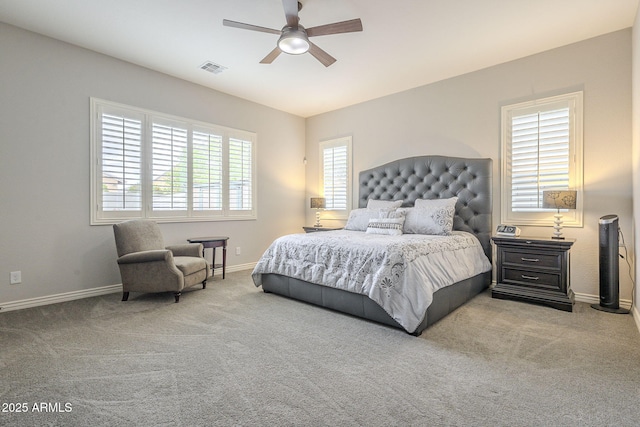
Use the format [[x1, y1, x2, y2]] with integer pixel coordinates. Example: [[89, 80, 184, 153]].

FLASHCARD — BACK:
[[358, 156, 492, 259]]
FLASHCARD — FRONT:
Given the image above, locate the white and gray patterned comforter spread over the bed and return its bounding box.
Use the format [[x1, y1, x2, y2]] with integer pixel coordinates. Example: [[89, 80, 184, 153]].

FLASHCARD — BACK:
[[252, 230, 491, 332]]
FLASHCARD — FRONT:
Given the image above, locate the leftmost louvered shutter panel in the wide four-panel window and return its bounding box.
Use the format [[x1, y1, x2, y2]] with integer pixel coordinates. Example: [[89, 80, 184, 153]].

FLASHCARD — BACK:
[[100, 113, 142, 211]]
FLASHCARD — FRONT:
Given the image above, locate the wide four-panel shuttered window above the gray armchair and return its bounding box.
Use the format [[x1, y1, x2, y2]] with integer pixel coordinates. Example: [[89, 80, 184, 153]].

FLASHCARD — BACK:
[[91, 98, 256, 224]]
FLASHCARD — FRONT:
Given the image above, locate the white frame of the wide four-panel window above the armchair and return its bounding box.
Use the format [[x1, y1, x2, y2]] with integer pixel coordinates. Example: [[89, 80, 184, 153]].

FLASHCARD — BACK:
[[90, 97, 258, 225]]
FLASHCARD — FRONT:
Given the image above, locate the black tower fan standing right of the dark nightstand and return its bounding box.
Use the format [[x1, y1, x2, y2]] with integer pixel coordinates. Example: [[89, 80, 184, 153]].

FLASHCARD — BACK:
[[591, 215, 629, 314]]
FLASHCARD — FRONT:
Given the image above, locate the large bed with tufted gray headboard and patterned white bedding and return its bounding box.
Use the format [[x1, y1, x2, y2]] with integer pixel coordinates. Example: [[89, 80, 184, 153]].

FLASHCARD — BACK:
[[252, 156, 492, 336]]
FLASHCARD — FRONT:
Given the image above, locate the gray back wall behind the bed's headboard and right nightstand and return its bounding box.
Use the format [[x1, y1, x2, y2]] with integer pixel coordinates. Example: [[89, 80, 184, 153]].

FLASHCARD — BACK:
[[306, 29, 634, 302]]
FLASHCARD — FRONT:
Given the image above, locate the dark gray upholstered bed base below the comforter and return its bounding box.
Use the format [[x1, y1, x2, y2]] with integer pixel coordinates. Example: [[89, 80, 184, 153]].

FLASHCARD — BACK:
[[262, 271, 491, 336]]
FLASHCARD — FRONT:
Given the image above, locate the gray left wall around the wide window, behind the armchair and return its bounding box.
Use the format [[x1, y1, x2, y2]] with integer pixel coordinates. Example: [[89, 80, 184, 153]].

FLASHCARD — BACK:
[[0, 23, 305, 306]]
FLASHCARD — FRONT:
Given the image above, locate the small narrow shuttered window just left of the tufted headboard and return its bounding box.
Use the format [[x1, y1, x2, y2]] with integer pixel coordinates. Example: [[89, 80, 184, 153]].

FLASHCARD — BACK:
[[320, 136, 351, 218]]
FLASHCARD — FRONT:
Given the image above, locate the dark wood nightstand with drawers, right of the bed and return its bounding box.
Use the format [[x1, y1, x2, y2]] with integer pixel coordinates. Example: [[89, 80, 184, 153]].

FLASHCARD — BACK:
[[491, 236, 575, 311]]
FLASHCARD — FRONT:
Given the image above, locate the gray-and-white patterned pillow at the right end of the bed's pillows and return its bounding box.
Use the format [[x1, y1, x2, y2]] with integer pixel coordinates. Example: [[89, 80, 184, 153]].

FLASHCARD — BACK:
[[398, 197, 458, 235]]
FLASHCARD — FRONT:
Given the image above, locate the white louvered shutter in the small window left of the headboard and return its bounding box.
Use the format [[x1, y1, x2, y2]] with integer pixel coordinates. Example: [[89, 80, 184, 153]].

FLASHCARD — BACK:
[[323, 145, 349, 210]]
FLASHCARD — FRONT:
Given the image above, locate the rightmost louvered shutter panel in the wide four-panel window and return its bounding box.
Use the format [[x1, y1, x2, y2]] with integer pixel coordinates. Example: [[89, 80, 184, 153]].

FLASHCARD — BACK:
[[228, 138, 253, 211]]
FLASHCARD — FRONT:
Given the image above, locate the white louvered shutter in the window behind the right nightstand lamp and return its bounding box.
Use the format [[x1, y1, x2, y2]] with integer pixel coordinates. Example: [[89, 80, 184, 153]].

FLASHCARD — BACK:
[[511, 108, 570, 212]]
